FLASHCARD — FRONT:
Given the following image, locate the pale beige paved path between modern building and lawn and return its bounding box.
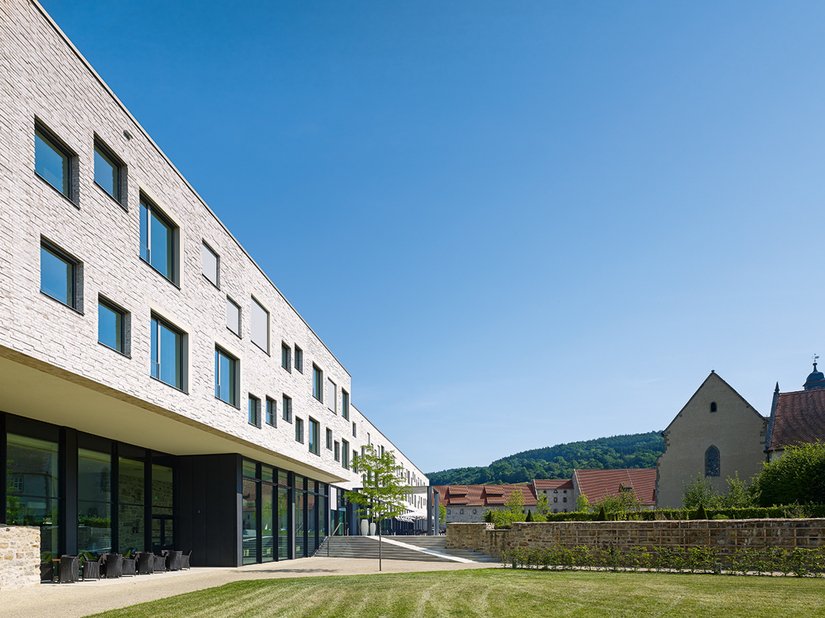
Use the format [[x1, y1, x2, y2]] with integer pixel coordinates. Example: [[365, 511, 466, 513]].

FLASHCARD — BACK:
[[0, 557, 491, 618]]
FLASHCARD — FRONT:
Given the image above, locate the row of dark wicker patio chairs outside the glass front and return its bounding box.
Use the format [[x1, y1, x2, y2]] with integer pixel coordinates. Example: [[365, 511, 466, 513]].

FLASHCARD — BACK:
[[40, 549, 192, 584]]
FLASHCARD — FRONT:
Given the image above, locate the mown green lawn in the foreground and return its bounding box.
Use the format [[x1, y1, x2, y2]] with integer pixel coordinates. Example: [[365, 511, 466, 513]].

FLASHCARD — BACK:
[[95, 569, 825, 618]]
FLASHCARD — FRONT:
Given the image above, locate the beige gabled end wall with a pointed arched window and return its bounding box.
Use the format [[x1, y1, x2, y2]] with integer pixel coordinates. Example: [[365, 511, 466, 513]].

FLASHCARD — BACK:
[[656, 371, 768, 508]]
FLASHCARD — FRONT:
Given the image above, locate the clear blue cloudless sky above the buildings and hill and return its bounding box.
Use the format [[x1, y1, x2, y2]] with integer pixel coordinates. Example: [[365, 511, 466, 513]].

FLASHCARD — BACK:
[[44, 0, 825, 471]]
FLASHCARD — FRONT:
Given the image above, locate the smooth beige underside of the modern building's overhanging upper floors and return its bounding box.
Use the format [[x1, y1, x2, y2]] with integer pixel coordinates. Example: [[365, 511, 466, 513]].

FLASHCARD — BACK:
[[0, 346, 348, 483]]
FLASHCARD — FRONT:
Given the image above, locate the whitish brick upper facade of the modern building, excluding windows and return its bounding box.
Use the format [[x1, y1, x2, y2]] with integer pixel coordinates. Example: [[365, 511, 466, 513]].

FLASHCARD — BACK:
[[0, 0, 428, 507]]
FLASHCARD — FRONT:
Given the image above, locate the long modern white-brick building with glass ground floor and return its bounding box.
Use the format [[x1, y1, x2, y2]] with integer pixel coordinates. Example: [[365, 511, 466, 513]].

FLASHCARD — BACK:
[[0, 0, 428, 566]]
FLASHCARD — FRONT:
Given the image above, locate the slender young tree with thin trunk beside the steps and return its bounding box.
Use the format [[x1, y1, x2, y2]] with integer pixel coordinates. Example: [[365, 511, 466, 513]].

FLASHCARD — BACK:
[[346, 444, 408, 571]]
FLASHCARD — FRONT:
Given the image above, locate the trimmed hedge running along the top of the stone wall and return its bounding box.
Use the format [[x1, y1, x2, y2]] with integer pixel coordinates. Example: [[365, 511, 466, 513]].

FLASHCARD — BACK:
[[536, 504, 825, 521]]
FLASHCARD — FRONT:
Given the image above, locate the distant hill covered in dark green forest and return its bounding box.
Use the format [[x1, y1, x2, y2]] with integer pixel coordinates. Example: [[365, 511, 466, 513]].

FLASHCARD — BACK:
[[427, 431, 665, 485]]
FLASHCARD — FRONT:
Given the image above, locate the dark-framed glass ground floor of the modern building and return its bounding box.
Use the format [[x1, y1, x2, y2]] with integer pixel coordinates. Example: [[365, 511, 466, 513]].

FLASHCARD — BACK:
[[0, 412, 338, 566]]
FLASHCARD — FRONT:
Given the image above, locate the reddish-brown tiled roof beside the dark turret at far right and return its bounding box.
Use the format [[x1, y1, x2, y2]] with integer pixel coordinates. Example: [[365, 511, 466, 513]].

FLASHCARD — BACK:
[[768, 389, 825, 451]]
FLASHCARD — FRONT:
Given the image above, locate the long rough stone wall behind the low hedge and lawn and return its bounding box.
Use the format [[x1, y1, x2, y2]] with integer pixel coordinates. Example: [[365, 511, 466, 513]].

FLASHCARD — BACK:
[[447, 518, 825, 558]]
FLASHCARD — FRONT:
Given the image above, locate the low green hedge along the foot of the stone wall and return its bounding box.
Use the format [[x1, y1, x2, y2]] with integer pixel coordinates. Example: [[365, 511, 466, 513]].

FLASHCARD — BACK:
[[501, 545, 825, 577]]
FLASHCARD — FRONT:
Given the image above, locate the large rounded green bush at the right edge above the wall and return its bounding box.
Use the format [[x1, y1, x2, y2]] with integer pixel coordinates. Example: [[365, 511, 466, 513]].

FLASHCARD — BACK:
[[753, 442, 825, 506]]
